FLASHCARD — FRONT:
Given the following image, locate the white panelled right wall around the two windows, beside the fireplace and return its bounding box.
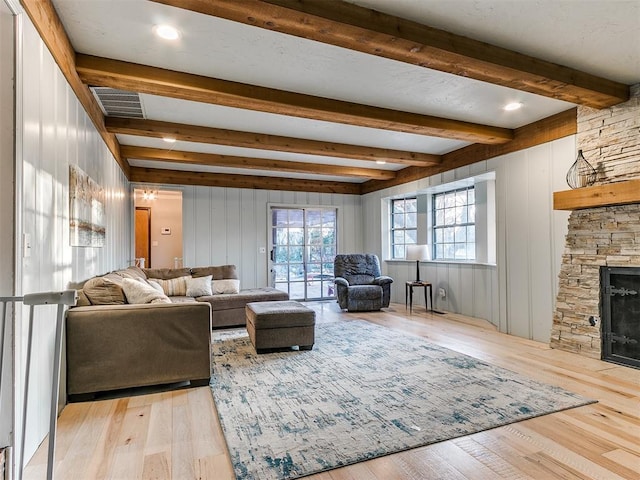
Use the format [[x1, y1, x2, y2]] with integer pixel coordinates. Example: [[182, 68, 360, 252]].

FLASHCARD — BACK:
[[362, 136, 576, 342]]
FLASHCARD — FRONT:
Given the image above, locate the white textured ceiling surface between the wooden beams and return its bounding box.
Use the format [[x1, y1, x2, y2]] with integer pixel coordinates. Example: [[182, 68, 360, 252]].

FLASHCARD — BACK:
[[53, 0, 640, 187]]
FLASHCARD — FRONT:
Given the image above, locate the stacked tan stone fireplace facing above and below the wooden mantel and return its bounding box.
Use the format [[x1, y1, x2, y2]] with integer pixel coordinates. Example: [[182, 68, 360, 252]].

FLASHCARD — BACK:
[[550, 84, 640, 359]]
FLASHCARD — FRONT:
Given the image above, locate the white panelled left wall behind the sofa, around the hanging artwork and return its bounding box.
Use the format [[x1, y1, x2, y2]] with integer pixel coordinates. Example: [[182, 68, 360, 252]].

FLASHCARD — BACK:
[[15, 14, 132, 466]]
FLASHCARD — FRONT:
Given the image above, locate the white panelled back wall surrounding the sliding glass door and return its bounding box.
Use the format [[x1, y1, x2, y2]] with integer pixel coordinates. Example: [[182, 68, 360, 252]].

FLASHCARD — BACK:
[[182, 187, 362, 288]]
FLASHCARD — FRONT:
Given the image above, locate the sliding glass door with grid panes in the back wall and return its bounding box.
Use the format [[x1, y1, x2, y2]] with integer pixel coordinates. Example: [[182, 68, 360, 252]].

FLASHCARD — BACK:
[[271, 207, 338, 300]]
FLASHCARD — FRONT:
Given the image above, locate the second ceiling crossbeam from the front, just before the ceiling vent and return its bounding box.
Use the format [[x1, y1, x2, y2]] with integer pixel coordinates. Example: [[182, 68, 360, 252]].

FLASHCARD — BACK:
[[76, 54, 513, 144]]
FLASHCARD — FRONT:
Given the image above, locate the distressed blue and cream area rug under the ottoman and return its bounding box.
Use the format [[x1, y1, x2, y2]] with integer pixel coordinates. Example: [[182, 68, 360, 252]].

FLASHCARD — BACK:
[[211, 321, 592, 480]]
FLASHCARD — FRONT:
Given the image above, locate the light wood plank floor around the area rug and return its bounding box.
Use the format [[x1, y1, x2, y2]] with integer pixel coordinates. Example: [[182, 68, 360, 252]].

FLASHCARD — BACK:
[[25, 303, 640, 480]]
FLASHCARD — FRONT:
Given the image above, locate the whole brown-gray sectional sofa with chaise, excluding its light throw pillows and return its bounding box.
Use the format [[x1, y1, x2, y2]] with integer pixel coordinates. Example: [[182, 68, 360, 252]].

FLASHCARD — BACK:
[[66, 265, 288, 400]]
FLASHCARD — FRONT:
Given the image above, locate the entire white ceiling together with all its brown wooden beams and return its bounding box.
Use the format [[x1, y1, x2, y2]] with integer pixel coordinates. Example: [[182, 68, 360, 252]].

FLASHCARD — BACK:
[[21, 0, 640, 194]]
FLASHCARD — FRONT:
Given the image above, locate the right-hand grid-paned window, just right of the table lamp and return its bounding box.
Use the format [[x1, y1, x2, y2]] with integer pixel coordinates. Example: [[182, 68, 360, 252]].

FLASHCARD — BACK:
[[433, 187, 476, 260]]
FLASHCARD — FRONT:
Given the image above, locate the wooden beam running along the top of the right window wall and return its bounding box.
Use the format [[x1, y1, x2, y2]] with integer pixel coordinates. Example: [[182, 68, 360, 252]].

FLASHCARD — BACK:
[[361, 108, 578, 194]]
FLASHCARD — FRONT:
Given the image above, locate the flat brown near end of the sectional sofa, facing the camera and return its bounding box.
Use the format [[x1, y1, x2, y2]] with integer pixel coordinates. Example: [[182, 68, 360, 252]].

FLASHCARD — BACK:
[[66, 302, 211, 401]]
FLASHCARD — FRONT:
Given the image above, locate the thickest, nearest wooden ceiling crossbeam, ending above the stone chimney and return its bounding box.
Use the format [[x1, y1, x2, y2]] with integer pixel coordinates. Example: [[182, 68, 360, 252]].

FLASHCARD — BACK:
[[154, 0, 629, 108]]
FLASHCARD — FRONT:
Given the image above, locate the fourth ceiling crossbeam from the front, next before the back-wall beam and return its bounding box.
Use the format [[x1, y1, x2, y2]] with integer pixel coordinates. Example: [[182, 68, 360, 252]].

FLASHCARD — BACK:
[[120, 145, 396, 180]]
